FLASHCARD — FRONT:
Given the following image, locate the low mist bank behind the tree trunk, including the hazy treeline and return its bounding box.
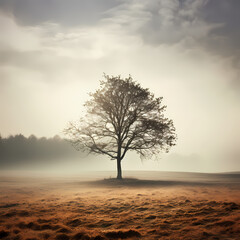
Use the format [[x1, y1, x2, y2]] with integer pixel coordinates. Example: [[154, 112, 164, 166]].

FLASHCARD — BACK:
[[0, 135, 240, 175]]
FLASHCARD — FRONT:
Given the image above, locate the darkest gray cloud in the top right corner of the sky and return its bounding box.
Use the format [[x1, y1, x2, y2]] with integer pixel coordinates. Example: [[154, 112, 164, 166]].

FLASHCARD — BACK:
[[201, 0, 240, 61]]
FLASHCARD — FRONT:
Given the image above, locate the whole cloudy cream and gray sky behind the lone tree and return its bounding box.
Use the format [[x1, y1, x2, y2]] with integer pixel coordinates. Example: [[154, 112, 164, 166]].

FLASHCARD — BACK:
[[0, 0, 240, 172]]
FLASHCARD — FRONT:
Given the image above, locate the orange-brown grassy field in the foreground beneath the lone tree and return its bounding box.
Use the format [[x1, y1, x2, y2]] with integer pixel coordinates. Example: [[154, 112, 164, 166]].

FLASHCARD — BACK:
[[0, 172, 240, 240]]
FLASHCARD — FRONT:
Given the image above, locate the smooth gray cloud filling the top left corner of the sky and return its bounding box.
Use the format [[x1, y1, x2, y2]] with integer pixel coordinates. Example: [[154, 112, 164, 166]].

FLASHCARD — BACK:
[[0, 0, 119, 26]]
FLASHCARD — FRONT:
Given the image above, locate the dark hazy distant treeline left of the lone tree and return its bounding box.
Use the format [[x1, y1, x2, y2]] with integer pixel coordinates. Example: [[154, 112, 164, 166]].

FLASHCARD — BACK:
[[0, 134, 80, 166]]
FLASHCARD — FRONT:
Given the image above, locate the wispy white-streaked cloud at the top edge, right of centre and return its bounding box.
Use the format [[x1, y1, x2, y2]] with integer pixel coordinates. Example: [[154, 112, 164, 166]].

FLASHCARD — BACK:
[[100, 0, 213, 45]]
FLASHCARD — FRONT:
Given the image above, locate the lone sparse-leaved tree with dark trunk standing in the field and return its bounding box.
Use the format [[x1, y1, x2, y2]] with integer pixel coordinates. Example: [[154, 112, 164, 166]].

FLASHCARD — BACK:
[[65, 75, 176, 179]]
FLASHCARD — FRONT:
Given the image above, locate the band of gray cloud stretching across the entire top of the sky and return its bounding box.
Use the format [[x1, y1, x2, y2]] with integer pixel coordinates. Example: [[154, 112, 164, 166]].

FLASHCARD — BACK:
[[0, 0, 240, 58]]
